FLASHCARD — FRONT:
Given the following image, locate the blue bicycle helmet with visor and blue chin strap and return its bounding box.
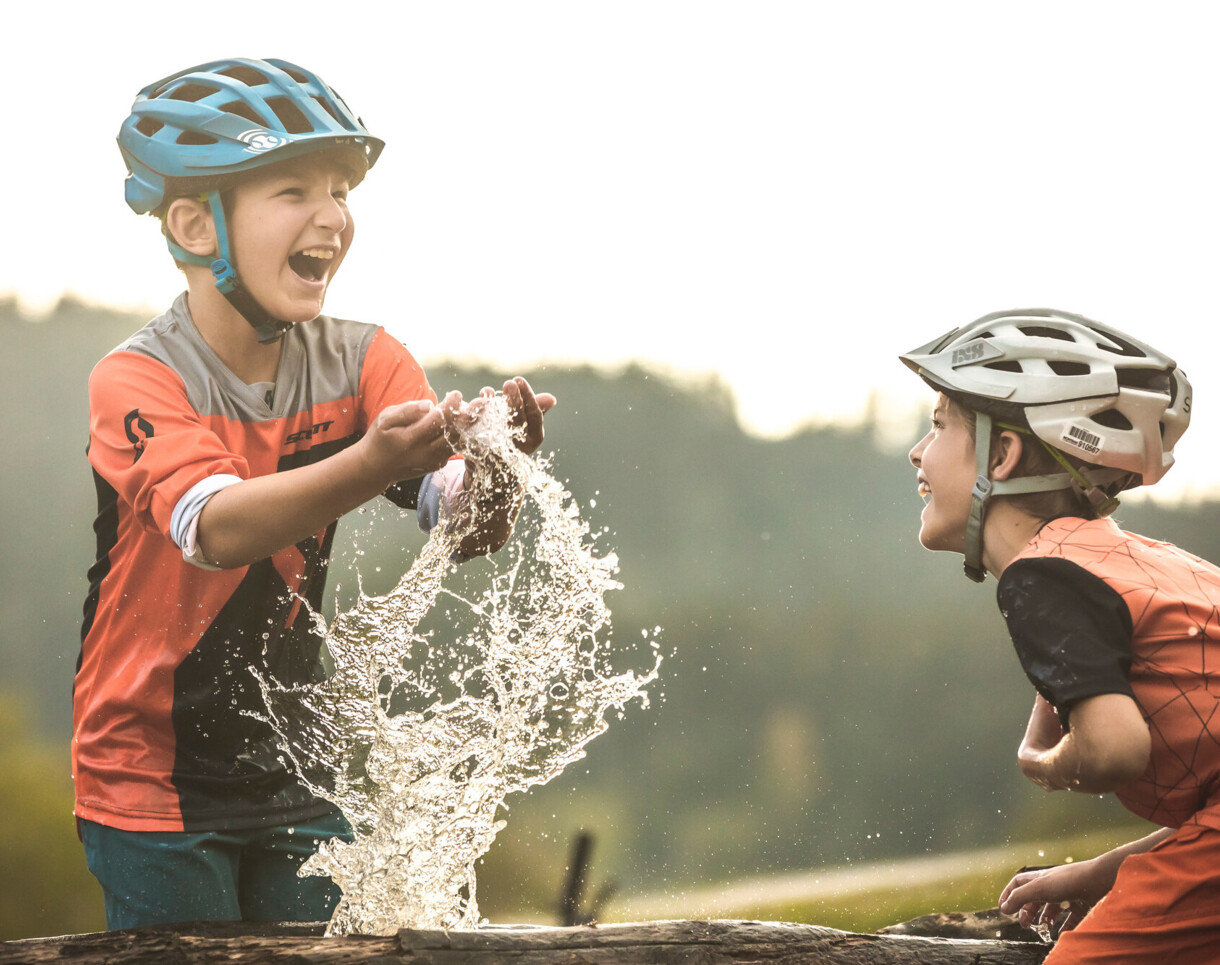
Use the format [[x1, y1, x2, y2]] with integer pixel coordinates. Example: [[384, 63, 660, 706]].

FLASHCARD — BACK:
[[118, 59, 386, 342]]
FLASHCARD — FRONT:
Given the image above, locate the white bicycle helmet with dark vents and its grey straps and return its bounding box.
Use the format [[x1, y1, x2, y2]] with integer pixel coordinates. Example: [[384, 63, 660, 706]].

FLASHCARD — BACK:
[[900, 309, 1191, 581]]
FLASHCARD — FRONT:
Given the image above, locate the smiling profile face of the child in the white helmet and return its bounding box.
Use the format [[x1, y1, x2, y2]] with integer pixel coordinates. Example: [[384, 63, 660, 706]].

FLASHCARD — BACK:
[[910, 395, 978, 553]]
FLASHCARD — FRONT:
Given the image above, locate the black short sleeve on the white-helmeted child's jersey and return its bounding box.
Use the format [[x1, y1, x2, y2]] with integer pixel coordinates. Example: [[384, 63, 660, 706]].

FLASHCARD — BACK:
[[996, 558, 1135, 728]]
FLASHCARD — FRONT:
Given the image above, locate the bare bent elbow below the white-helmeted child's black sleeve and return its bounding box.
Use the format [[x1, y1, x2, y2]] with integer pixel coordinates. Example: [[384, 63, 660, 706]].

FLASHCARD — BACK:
[[1017, 694, 1152, 794]]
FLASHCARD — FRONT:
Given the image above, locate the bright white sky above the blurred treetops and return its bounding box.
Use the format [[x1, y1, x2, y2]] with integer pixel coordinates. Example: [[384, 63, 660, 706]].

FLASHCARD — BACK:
[[7, 0, 1220, 493]]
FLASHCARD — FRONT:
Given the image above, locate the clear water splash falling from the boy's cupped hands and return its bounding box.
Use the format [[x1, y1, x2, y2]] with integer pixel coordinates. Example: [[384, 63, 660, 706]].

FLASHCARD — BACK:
[[260, 395, 661, 935]]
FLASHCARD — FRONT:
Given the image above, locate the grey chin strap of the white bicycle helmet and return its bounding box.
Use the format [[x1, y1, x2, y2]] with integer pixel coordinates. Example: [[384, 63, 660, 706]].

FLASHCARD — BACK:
[[964, 411, 1127, 583]]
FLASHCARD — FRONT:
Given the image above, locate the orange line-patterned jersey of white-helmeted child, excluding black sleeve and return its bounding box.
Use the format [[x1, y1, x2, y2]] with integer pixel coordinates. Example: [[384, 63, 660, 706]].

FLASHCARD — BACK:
[[1002, 517, 1220, 828]]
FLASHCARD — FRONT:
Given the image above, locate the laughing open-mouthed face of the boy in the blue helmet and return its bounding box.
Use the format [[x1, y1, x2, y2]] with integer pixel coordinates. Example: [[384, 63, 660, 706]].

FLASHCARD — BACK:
[[227, 154, 354, 322]]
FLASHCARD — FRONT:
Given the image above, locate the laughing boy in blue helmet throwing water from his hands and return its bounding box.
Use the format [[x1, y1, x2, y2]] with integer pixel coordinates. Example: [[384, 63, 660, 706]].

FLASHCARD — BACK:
[[72, 60, 554, 928]]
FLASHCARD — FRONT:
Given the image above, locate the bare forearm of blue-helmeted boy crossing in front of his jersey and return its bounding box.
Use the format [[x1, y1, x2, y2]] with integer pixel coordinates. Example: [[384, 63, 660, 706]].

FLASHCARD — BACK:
[[196, 447, 393, 569]]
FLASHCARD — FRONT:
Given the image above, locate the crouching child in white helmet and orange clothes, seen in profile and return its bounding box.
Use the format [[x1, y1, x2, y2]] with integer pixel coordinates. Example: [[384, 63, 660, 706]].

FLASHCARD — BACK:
[[902, 309, 1220, 965]]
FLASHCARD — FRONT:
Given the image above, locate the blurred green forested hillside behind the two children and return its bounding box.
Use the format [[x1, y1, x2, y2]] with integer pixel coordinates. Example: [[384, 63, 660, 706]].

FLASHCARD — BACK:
[[0, 300, 1220, 938]]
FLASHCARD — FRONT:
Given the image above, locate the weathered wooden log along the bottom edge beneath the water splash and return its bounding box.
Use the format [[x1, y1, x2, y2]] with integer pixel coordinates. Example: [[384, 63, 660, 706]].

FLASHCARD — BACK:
[[0, 920, 1049, 965]]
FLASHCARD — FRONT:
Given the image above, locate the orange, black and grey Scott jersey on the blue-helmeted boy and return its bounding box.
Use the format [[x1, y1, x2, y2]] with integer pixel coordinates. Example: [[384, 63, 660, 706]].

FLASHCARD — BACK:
[[72, 295, 436, 831]]
